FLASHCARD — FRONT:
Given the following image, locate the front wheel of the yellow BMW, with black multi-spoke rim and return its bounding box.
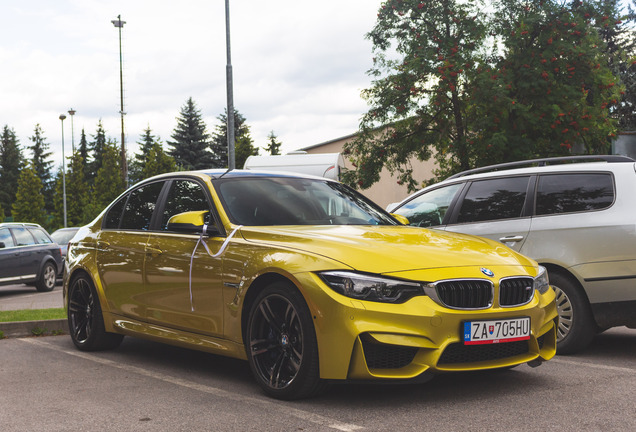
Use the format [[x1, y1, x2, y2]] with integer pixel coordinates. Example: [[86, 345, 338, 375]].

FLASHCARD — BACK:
[[245, 282, 325, 400]]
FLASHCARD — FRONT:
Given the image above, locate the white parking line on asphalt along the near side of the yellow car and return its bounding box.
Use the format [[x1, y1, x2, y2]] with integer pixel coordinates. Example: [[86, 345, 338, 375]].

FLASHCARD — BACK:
[[19, 338, 363, 432]]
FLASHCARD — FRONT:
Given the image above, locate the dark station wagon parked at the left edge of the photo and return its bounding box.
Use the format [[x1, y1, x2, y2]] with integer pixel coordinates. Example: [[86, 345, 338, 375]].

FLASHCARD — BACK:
[[0, 223, 62, 291]]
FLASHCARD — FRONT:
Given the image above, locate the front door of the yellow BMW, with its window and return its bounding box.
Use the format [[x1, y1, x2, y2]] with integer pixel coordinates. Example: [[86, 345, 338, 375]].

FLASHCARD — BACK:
[[144, 178, 225, 336]]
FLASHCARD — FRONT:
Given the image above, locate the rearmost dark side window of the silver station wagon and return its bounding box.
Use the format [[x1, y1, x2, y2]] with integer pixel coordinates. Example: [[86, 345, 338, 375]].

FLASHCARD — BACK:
[[536, 174, 614, 215]]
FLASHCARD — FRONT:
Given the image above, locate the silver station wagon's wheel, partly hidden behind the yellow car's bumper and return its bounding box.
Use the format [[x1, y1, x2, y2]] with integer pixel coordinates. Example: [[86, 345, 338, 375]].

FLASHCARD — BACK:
[[550, 273, 597, 354]]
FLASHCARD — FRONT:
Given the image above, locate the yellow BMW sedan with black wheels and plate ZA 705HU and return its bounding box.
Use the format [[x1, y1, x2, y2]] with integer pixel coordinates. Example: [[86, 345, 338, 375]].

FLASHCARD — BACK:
[[64, 170, 558, 399]]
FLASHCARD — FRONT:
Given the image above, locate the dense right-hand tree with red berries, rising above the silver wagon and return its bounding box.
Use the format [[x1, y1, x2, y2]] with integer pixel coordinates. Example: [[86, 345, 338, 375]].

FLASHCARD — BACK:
[[475, 0, 621, 162]]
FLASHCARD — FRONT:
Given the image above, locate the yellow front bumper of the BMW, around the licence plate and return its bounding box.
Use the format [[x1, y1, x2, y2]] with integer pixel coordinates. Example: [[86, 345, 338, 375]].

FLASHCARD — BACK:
[[296, 273, 558, 380]]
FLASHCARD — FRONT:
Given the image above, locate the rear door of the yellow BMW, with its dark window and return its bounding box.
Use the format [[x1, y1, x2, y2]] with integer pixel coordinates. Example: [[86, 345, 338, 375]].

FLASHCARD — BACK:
[[96, 181, 164, 320]]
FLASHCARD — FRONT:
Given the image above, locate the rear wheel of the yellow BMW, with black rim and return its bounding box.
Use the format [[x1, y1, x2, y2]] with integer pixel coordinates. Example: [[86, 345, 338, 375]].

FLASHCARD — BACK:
[[68, 275, 124, 351]]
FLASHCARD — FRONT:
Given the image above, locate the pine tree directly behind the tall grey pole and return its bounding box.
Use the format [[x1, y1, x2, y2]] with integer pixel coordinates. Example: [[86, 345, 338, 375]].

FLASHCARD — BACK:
[[212, 109, 258, 168]]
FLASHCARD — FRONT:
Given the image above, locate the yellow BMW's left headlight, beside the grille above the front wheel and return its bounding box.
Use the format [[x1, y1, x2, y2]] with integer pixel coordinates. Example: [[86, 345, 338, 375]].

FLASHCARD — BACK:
[[318, 271, 424, 303]]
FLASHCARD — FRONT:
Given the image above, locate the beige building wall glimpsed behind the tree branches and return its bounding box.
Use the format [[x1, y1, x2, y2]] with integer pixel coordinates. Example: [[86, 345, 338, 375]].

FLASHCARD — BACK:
[[300, 134, 435, 208]]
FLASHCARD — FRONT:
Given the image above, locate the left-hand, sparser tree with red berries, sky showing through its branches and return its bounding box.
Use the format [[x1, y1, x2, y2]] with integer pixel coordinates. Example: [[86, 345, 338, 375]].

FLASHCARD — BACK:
[[343, 0, 486, 189]]
